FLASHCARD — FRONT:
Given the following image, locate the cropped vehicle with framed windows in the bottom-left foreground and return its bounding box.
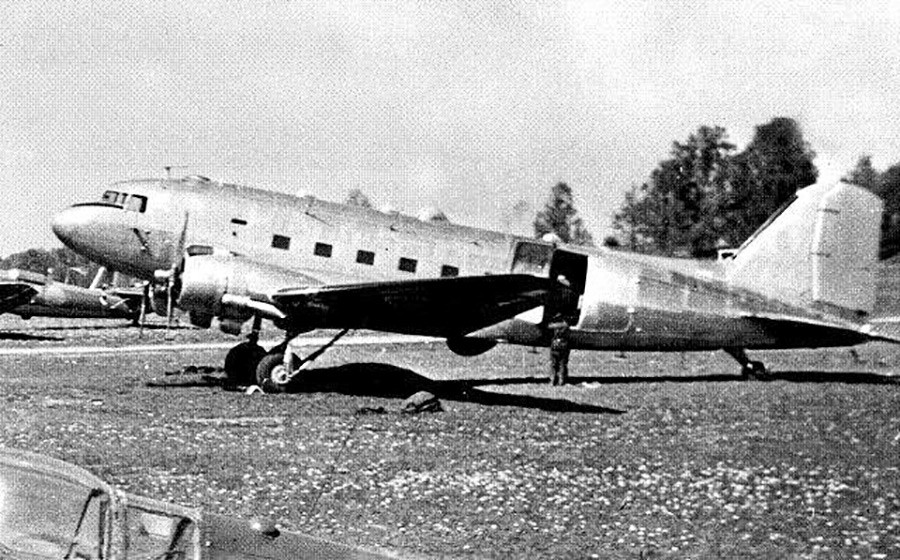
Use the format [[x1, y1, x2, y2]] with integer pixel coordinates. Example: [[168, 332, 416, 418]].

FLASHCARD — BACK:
[[0, 448, 398, 560]]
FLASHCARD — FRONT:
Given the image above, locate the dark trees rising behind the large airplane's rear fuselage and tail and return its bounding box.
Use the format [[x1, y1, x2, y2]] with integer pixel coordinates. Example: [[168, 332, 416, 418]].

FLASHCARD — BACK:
[[534, 117, 900, 258]]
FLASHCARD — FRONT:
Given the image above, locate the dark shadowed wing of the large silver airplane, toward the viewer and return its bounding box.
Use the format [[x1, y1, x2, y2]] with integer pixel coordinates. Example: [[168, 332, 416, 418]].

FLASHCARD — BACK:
[[272, 274, 551, 337]]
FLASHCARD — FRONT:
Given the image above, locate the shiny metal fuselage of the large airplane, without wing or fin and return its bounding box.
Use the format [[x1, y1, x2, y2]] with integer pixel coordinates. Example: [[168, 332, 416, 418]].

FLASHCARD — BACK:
[[54, 179, 864, 350]]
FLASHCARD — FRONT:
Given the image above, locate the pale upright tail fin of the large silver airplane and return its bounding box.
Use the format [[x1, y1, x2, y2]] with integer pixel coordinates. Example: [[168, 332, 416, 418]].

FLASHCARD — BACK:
[[728, 183, 882, 317]]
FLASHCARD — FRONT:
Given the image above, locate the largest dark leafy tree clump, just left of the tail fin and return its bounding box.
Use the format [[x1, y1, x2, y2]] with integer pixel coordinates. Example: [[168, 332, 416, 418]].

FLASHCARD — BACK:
[[614, 118, 817, 257]]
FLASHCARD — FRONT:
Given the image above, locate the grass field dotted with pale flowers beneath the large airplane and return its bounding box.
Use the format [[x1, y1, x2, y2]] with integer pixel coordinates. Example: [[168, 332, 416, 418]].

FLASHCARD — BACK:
[[0, 264, 900, 558]]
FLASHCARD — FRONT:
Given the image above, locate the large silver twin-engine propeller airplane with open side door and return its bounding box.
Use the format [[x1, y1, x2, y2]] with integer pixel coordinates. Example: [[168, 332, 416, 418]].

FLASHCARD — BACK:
[[53, 176, 900, 392]]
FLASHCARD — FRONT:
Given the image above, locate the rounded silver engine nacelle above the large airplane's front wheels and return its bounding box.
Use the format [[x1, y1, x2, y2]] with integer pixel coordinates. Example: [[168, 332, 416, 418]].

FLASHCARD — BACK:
[[178, 254, 310, 333]]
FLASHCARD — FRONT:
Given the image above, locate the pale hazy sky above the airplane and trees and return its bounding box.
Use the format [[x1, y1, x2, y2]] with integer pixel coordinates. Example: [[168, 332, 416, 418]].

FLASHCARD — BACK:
[[0, 0, 900, 256]]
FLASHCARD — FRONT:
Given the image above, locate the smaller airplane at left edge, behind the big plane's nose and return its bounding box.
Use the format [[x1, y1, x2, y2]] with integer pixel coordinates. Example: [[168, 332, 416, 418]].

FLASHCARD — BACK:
[[0, 269, 142, 321]]
